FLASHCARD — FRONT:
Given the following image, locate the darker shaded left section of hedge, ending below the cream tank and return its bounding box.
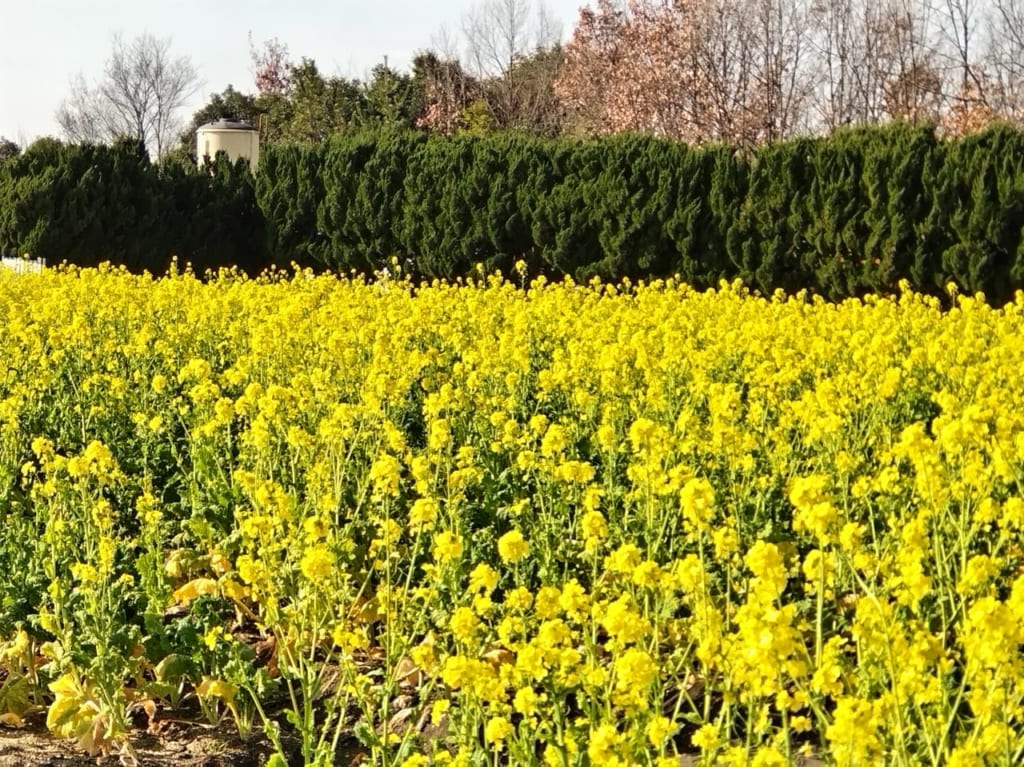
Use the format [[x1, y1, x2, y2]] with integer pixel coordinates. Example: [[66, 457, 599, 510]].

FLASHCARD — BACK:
[[0, 139, 268, 273]]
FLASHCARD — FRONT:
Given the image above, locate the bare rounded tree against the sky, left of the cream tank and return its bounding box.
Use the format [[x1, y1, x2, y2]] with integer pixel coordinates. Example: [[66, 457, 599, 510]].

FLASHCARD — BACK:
[[56, 33, 199, 157]]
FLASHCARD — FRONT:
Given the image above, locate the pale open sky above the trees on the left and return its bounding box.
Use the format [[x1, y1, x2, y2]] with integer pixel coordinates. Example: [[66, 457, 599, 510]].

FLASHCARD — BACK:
[[0, 0, 586, 143]]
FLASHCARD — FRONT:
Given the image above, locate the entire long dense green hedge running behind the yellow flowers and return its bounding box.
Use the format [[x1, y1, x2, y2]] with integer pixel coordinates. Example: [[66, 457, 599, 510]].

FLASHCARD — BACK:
[[0, 125, 1024, 301]]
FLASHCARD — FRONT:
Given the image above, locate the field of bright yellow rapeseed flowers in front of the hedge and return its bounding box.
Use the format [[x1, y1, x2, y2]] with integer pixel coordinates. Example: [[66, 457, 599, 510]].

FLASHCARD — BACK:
[[0, 262, 1024, 767]]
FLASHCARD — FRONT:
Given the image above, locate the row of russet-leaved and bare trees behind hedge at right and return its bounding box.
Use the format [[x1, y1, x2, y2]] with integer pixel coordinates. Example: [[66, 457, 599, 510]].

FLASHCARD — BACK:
[[555, 0, 1024, 145]]
